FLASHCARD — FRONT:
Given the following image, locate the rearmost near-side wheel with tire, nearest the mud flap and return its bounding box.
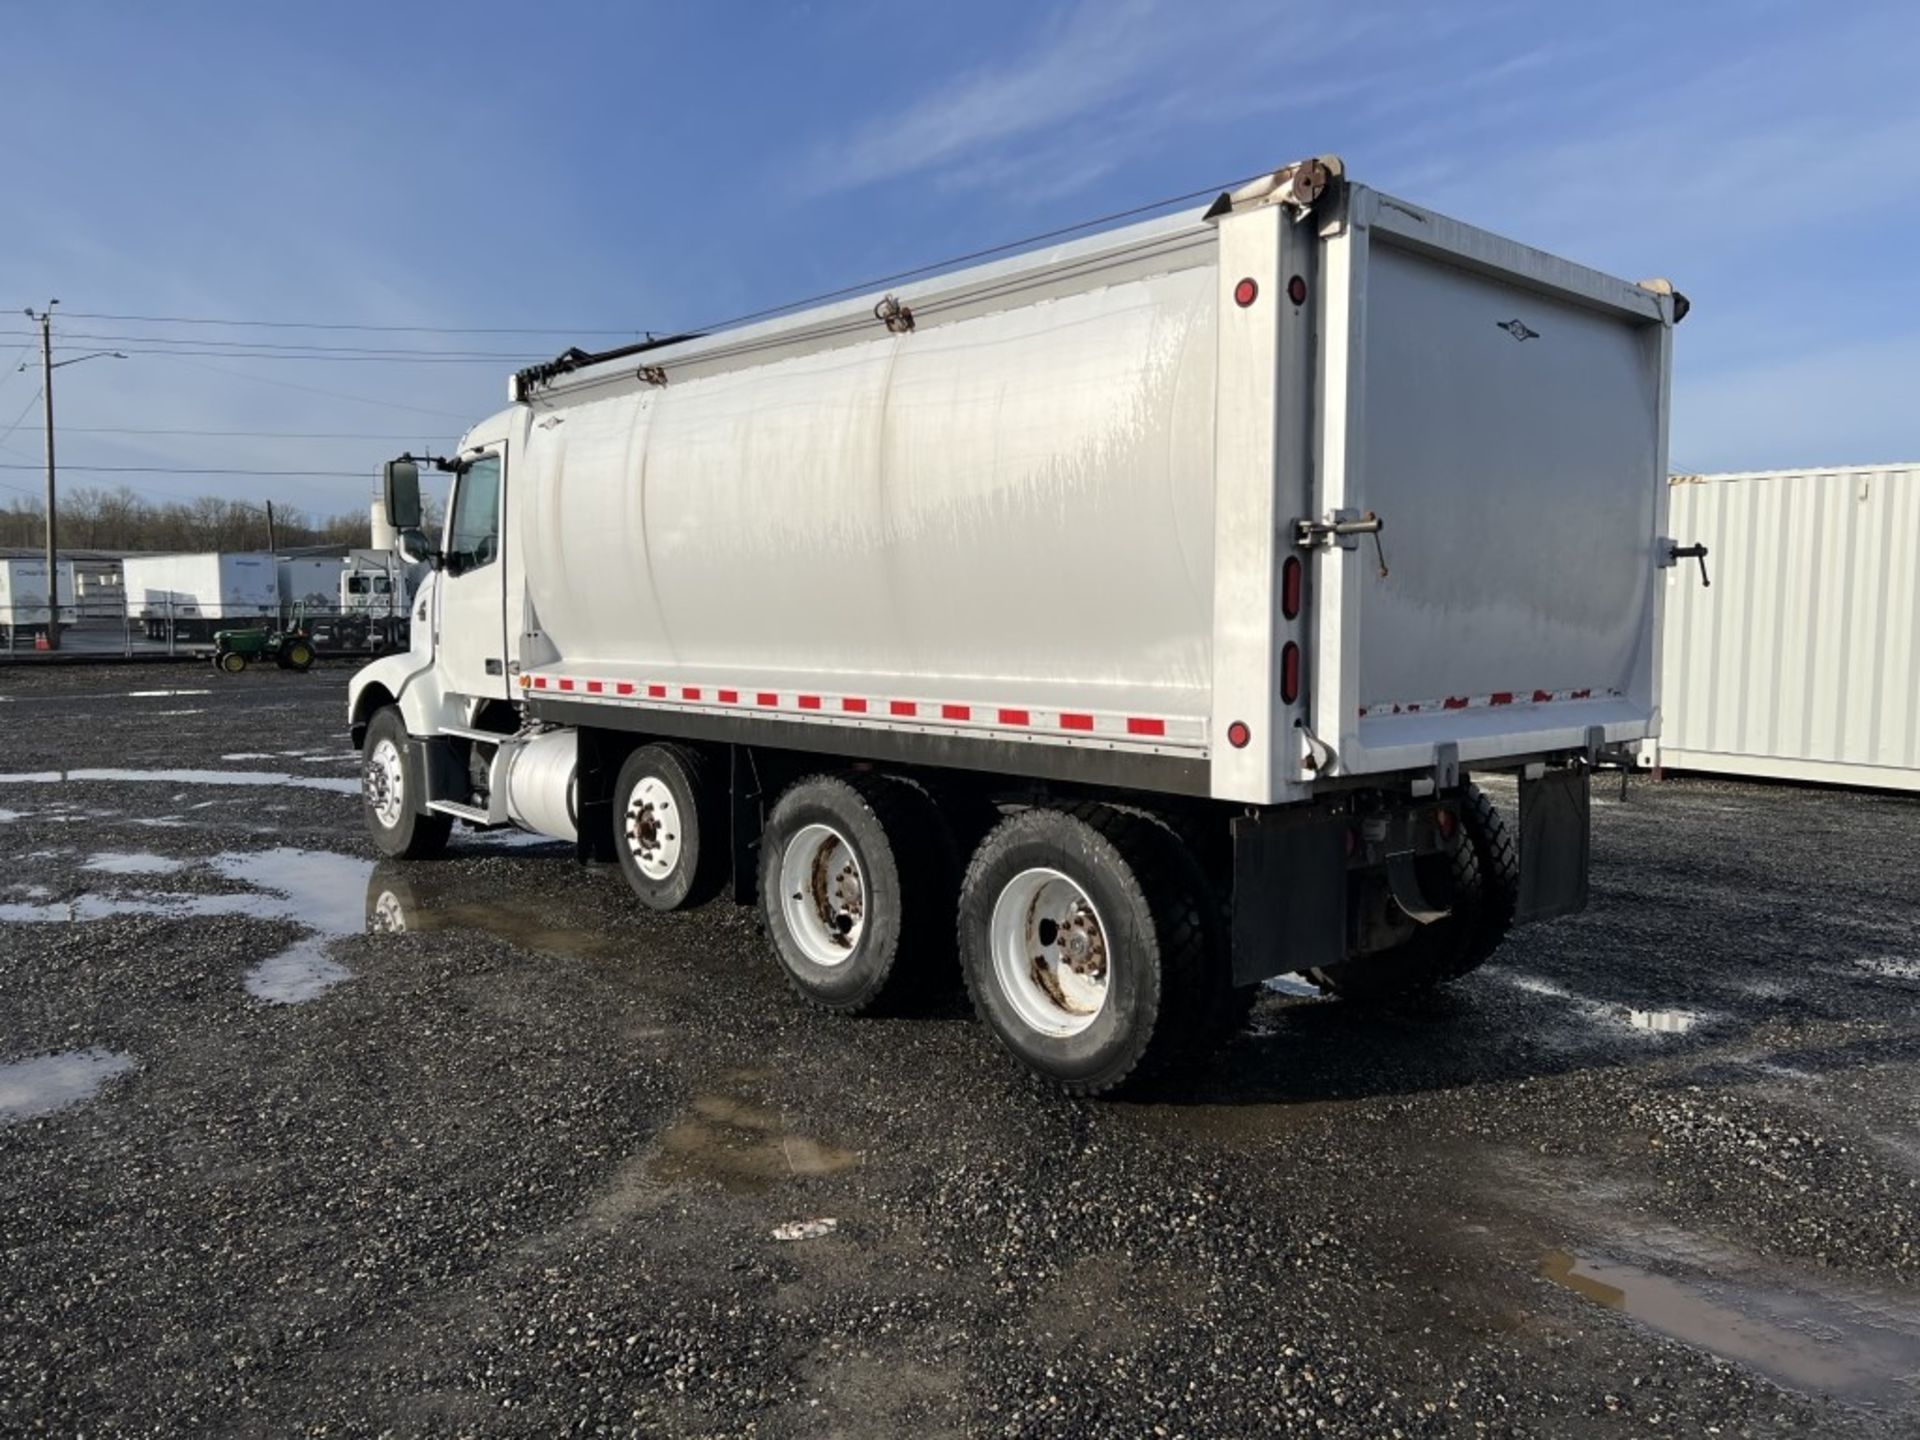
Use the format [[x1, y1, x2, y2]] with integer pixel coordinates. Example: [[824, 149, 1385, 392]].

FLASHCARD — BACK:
[[960, 804, 1219, 1094]]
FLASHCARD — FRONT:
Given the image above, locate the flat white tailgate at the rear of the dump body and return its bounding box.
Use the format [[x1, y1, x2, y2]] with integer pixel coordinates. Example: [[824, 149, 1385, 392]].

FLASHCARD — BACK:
[[1304, 188, 1672, 774]]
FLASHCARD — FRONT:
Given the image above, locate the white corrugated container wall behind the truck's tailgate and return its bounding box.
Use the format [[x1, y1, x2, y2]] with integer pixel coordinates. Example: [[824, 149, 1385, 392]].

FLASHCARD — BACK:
[[1647, 465, 1920, 791]]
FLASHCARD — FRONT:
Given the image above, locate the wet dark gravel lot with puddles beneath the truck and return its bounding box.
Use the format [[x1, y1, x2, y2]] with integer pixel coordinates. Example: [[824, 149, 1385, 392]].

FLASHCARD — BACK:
[[0, 666, 1920, 1436]]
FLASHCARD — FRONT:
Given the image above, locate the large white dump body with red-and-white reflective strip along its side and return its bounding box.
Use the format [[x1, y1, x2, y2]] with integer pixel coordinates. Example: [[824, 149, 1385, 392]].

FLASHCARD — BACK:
[[483, 168, 1674, 803]]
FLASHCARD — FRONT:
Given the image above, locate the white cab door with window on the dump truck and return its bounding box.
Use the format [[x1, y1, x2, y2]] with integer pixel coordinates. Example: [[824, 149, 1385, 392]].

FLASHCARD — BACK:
[[436, 444, 507, 699]]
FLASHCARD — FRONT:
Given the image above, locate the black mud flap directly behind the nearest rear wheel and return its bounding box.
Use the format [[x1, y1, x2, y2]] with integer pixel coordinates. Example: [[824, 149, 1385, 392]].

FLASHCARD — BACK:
[[1233, 814, 1346, 985]]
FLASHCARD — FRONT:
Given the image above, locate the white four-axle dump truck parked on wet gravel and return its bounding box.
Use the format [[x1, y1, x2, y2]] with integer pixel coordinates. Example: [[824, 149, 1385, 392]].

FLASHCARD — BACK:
[[349, 157, 1692, 1094]]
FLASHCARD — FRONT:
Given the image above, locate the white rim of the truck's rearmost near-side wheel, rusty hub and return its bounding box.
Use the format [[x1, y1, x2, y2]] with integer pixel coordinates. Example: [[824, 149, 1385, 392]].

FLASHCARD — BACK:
[[989, 868, 1112, 1039]]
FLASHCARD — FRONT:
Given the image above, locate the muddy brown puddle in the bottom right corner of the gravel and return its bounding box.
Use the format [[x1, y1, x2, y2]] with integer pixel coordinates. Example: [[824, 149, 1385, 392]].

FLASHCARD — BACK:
[[1540, 1250, 1920, 1409]]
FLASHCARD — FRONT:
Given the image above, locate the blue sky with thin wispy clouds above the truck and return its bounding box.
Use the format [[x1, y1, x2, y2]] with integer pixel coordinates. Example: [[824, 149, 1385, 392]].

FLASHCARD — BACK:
[[0, 0, 1920, 511]]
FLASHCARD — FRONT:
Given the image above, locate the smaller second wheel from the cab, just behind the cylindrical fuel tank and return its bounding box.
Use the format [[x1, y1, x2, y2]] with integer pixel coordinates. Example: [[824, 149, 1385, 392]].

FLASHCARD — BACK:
[[612, 745, 726, 910]]
